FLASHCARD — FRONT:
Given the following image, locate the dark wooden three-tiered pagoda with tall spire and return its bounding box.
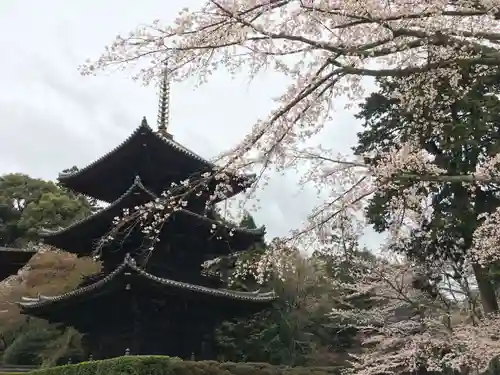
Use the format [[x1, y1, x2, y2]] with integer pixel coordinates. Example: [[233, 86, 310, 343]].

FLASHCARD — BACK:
[[19, 66, 276, 359]]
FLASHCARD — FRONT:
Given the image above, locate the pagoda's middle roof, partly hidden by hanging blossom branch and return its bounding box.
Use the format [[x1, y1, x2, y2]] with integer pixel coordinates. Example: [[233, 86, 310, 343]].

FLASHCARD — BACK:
[[40, 177, 265, 261]]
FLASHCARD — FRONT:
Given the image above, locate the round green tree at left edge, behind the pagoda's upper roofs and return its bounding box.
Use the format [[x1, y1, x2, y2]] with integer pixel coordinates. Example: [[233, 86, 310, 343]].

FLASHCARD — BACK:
[[0, 173, 94, 246]]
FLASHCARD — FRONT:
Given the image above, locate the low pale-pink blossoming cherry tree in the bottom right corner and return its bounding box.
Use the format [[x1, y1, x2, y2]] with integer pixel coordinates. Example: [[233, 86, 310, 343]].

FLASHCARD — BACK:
[[331, 250, 500, 375]]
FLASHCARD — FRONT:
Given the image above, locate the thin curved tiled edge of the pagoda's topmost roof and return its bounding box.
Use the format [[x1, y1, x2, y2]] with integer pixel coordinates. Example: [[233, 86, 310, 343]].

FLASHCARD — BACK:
[[58, 119, 215, 184]]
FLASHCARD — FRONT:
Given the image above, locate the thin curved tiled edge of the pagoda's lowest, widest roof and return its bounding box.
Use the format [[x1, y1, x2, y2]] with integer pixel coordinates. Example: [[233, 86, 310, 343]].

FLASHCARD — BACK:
[[17, 255, 277, 311]]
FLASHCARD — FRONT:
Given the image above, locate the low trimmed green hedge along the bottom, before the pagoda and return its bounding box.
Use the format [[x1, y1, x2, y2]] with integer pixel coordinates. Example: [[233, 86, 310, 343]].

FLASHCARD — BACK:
[[30, 356, 339, 375]]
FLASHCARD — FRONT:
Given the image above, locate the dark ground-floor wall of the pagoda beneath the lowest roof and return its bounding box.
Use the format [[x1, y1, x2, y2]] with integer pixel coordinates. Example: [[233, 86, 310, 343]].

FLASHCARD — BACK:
[[83, 296, 221, 359]]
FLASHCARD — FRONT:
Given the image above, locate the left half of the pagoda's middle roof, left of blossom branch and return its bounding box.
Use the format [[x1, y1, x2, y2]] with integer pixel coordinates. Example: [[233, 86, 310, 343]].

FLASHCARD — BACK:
[[39, 176, 157, 255]]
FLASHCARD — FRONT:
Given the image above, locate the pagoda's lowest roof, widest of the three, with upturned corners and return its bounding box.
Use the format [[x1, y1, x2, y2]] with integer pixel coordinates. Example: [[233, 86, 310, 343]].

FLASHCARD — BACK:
[[18, 254, 277, 313]]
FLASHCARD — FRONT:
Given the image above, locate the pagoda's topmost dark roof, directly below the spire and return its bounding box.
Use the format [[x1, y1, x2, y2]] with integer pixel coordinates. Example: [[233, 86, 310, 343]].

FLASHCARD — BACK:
[[59, 119, 251, 202]]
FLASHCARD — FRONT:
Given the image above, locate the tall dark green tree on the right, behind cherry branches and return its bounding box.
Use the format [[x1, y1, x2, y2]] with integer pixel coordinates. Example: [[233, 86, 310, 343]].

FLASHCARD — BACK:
[[350, 69, 500, 374]]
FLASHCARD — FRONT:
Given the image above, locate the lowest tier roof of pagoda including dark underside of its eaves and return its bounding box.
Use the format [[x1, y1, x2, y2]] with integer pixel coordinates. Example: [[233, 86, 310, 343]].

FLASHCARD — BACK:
[[18, 254, 276, 316]]
